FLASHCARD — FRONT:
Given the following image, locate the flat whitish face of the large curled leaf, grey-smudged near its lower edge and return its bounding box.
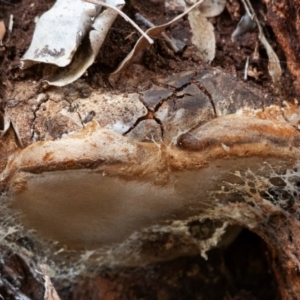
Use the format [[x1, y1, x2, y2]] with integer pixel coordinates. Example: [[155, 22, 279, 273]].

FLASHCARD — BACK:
[[21, 0, 99, 68]]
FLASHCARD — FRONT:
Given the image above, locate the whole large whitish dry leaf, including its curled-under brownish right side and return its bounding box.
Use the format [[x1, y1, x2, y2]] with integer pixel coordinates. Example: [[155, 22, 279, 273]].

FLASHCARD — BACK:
[[21, 0, 125, 86]]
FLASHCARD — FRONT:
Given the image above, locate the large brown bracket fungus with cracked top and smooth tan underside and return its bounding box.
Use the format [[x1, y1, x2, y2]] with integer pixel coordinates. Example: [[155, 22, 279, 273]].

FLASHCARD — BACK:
[[0, 69, 300, 294]]
